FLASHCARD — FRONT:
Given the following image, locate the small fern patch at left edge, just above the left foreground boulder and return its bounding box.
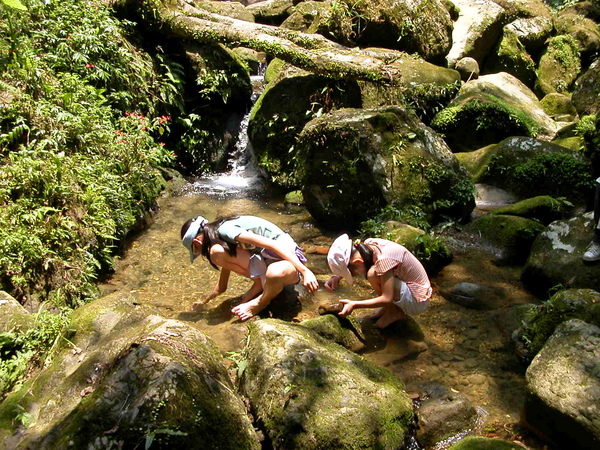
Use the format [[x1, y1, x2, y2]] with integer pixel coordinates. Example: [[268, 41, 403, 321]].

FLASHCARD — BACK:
[[0, 310, 69, 396]]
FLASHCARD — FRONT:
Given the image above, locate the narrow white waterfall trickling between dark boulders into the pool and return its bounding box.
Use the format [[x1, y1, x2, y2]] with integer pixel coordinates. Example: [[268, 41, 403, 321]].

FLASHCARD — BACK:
[[186, 63, 266, 196]]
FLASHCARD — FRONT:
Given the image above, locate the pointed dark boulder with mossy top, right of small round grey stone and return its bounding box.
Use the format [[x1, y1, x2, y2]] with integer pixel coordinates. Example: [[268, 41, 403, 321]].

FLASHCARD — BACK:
[[482, 28, 536, 88]]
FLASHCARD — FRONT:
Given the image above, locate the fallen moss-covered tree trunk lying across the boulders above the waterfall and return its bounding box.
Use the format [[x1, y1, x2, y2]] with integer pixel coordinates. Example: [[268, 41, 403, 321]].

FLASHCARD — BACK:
[[114, 0, 402, 84]]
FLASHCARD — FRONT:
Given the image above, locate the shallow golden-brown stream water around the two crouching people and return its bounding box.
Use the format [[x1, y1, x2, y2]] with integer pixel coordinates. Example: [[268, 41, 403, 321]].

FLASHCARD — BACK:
[[101, 183, 534, 446]]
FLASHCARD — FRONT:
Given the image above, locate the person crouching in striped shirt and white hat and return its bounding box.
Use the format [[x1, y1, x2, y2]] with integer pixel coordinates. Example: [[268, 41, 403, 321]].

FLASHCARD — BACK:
[[325, 234, 432, 328]]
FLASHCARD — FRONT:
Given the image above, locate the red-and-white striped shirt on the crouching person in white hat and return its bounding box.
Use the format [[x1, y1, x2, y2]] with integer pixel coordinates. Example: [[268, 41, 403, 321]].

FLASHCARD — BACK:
[[365, 238, 433, 302]]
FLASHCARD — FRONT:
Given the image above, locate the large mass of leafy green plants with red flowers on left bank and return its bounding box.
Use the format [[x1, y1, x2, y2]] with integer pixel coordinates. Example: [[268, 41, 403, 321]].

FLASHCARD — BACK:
[[0, 0, 181, 306]]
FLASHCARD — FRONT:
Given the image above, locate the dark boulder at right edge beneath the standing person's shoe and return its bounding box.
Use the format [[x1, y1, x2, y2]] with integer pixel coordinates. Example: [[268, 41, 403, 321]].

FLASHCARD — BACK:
[[521, 213, 600, 297]]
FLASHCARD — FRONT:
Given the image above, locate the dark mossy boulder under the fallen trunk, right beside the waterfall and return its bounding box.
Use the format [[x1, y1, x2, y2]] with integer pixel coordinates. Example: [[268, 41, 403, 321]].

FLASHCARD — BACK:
[[248, 56, 460, 189]]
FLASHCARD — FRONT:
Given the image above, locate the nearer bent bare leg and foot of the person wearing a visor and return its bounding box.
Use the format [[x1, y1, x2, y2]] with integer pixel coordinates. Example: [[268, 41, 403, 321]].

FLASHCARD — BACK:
[[231, 261, 298, 321]]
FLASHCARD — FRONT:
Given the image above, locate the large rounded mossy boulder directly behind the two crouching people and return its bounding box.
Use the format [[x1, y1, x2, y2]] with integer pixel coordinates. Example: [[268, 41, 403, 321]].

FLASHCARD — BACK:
[[295, 107, 475, 230]]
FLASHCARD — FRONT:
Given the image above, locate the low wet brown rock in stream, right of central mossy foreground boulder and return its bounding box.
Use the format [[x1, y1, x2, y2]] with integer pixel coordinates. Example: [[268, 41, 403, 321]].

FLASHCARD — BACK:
[[416, 383, 478, 448]]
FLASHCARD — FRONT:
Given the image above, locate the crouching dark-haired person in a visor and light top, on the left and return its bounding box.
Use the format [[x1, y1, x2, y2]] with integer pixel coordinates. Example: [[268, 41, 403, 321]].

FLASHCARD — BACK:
[[181, 216, 319, 320]]
